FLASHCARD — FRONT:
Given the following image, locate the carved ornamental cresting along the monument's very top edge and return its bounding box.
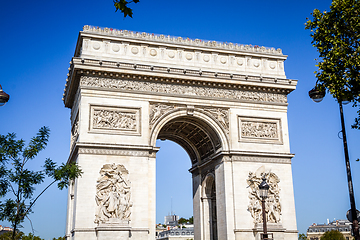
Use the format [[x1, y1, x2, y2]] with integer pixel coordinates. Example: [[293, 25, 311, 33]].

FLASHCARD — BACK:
[[83, 25, 283, 56]]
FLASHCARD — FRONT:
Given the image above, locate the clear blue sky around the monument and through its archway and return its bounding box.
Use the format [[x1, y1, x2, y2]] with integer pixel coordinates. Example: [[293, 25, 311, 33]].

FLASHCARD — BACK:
[[0, 0, 360, 239]]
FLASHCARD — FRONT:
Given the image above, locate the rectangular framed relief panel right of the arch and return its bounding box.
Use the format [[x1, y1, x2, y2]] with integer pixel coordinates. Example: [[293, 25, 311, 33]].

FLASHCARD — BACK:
[[238, 116, 282, 144]]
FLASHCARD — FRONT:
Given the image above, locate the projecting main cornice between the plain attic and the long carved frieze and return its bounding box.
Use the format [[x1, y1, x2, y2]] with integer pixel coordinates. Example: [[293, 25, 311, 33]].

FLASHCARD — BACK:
[[63, 58, 297, 107]]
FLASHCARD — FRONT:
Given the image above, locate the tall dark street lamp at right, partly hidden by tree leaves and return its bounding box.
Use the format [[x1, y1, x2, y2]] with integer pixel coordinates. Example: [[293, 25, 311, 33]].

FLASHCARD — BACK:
[[309, 87, 360, 240]]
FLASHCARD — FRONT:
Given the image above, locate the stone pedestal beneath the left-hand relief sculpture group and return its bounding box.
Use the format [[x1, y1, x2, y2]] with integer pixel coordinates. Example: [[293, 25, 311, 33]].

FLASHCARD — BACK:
[[95, 218, 131, 240]]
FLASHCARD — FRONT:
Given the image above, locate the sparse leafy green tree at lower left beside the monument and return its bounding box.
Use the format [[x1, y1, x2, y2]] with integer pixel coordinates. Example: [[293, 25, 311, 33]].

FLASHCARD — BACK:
[[0, 127, 82, 239]]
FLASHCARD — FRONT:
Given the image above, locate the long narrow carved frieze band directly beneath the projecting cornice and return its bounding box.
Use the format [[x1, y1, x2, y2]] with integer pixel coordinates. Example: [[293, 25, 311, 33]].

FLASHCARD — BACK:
[[80, 76, 287, 103]]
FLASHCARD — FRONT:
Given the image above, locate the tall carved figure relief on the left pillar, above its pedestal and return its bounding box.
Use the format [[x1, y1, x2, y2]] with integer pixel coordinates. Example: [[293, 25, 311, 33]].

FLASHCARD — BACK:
[[95, 163, 132, 224]]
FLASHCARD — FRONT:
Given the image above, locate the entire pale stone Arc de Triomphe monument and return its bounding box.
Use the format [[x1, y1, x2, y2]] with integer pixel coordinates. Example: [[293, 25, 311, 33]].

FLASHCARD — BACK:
[[63, 26, 297, 240]]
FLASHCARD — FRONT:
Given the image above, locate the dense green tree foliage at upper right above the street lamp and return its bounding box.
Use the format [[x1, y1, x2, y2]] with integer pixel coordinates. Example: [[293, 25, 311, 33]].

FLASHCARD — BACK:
[[305, 0, 360, 129]]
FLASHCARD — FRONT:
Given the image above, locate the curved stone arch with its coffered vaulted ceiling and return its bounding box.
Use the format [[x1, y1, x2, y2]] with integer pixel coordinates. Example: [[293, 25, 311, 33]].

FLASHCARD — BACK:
[[150, 108, 229, 165]]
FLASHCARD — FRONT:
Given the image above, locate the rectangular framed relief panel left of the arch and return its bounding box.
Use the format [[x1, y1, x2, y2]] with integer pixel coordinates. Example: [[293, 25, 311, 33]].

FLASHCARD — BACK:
[[90, 106, 140, 134]]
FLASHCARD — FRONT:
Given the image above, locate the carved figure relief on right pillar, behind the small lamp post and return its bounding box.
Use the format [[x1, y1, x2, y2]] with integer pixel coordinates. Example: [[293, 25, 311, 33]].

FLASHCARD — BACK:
[[247, 166, 281, 224]]
